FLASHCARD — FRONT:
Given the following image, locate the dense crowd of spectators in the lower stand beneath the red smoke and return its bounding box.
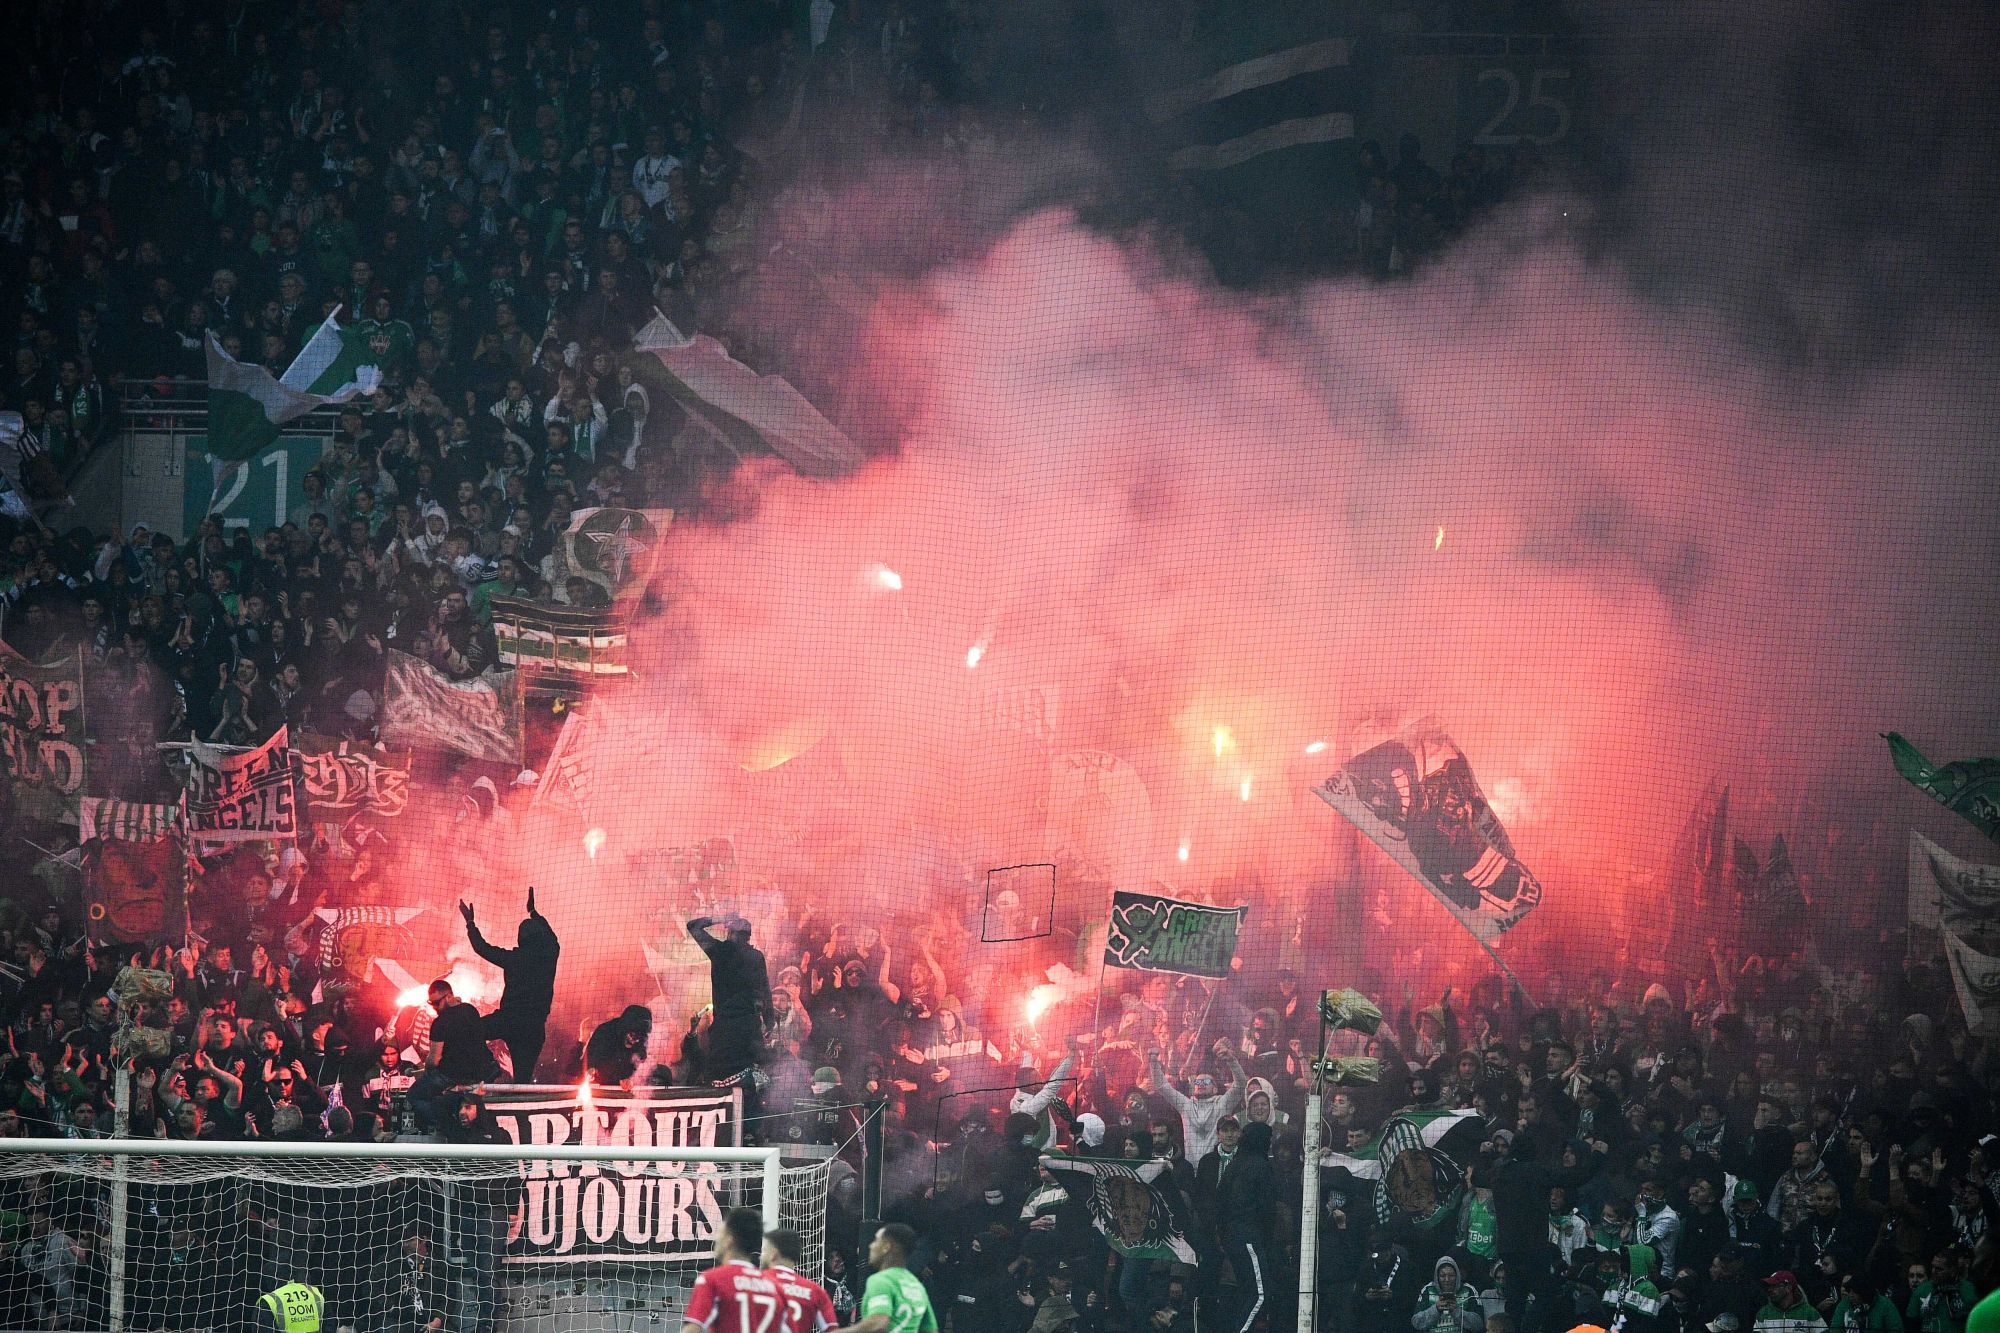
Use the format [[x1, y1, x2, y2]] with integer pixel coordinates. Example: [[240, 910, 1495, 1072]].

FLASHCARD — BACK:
[[0, 876, 2000, 1333]]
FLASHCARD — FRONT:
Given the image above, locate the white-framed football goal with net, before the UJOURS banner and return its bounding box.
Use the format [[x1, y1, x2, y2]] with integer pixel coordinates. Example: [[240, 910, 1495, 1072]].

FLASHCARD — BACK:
[[0, 1139, 828, 1333]]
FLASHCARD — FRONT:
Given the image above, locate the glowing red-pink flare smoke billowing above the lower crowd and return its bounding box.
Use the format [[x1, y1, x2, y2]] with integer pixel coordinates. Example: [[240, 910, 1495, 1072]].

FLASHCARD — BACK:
[[426, 198, 2000, 1013]]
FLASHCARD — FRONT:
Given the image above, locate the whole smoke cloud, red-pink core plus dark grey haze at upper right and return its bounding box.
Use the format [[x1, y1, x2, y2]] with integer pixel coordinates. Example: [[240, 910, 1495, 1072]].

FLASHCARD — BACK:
[[418, 6, 2000, 1013]]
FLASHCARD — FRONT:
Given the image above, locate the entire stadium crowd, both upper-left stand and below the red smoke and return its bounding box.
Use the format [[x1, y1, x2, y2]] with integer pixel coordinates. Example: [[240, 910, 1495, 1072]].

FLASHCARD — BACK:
[[0, 0, 2000, 1333]]
